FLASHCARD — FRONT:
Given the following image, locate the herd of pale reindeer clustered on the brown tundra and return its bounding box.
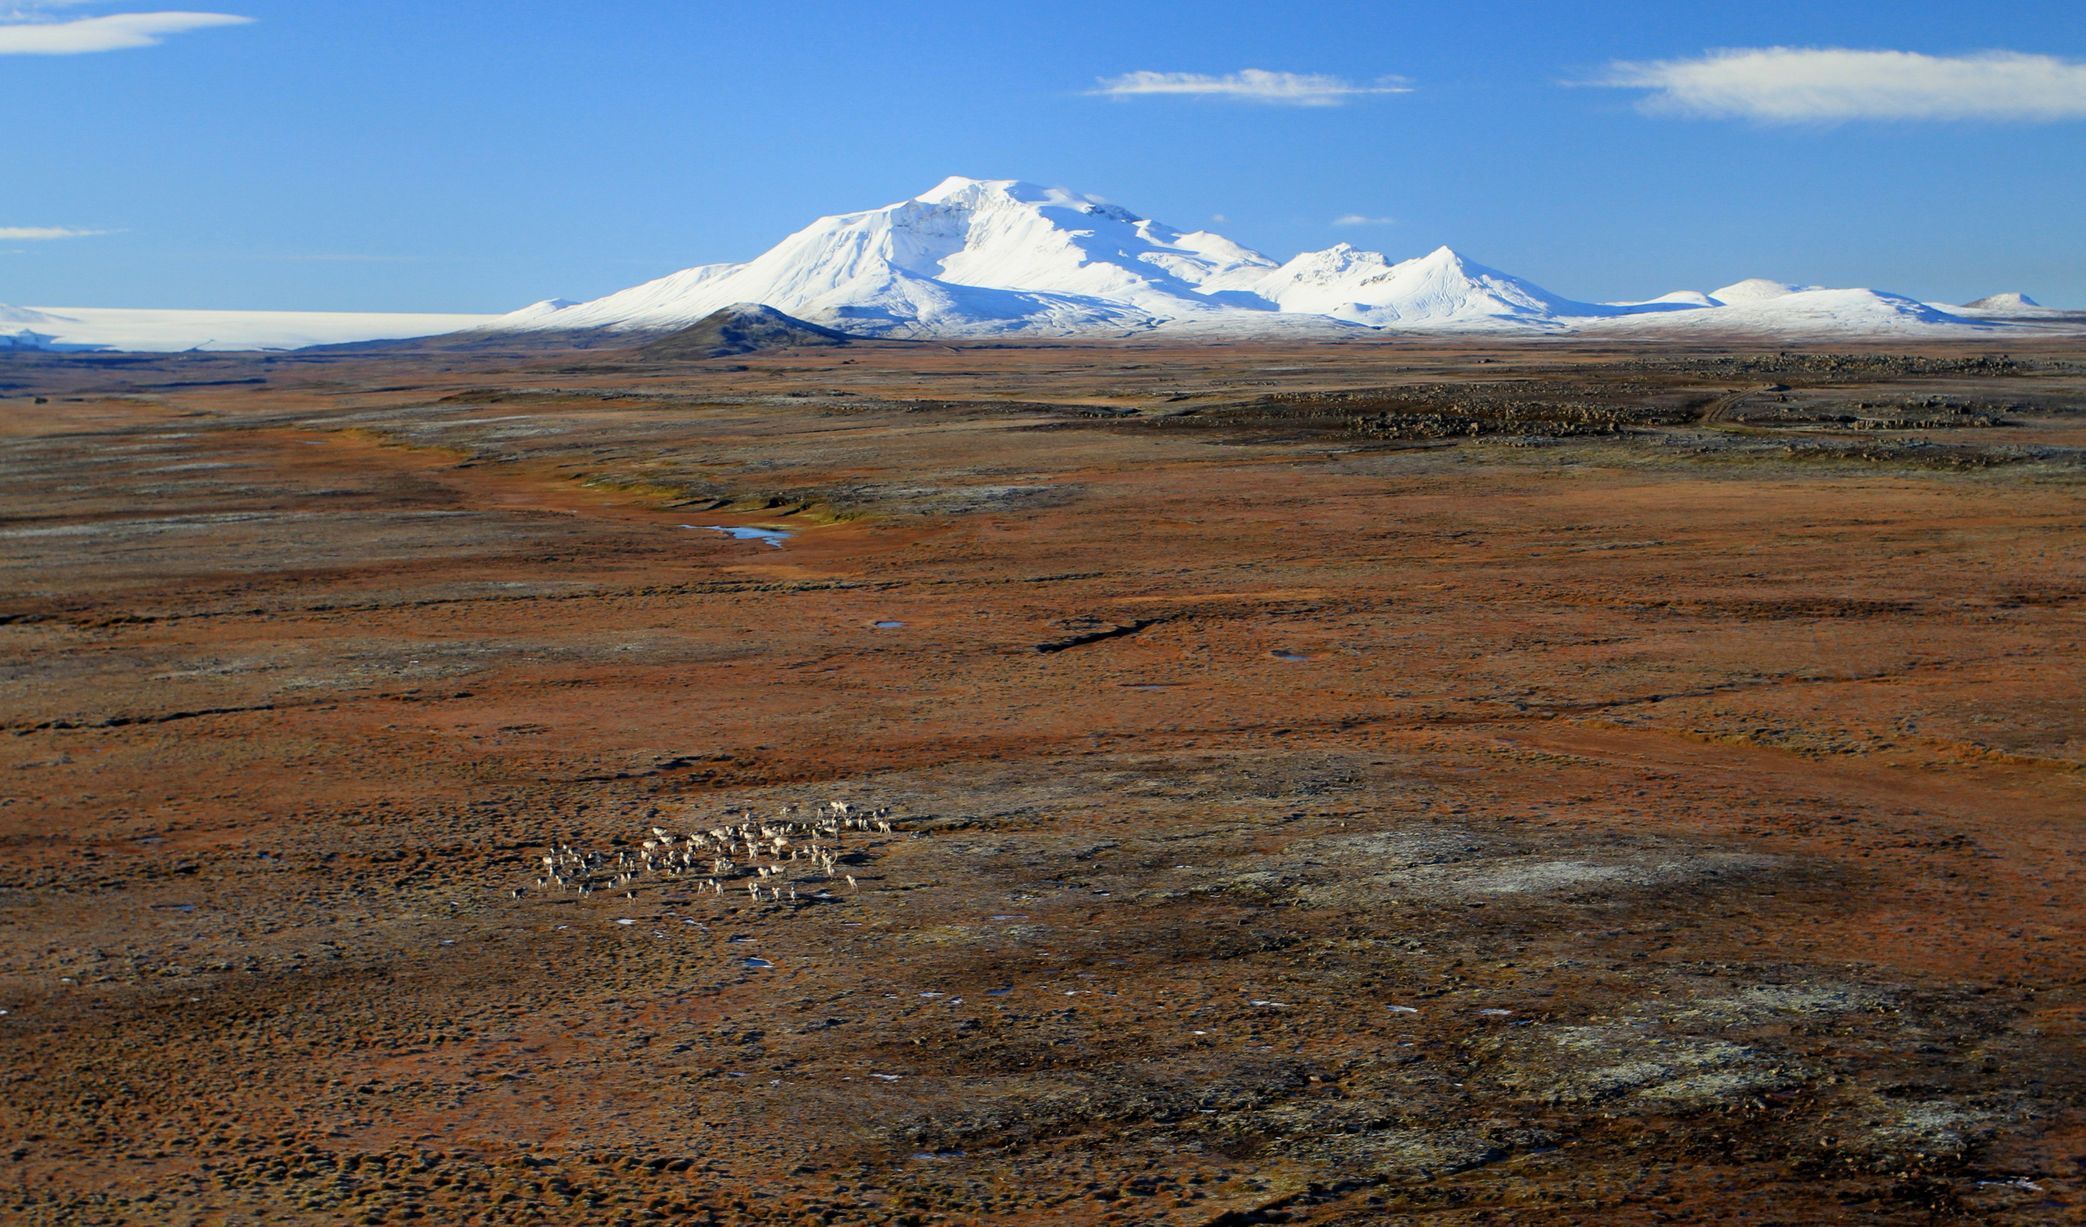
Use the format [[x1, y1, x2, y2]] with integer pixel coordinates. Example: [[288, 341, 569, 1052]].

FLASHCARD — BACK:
[[509, 801, 895, 904]]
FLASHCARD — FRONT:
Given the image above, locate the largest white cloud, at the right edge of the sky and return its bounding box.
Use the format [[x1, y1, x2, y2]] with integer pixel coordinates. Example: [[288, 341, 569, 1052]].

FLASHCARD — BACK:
[[1594, 46, 2086, 123]]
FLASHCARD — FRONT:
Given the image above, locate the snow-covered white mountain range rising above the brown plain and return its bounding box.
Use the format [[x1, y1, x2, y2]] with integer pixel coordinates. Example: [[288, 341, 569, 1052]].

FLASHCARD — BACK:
[[490, 177, 2069, 336]]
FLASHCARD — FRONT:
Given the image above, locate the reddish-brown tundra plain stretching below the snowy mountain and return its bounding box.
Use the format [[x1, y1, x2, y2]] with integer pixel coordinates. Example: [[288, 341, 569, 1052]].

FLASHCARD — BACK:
[[0, 340, 2086, 1225]]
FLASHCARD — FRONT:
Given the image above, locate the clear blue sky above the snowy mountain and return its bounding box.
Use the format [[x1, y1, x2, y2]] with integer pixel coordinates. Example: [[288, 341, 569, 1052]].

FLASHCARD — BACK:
[[0, 0, 2086, 311]]
